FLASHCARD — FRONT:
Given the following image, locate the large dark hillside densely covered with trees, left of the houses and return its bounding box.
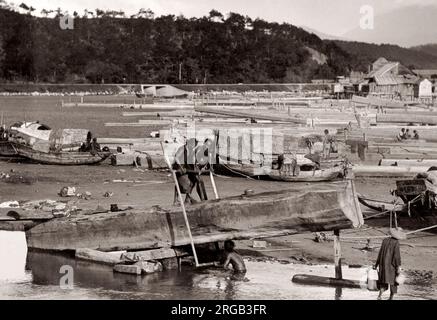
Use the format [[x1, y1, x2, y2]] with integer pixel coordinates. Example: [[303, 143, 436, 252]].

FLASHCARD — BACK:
[[0, 9, 364, 83]]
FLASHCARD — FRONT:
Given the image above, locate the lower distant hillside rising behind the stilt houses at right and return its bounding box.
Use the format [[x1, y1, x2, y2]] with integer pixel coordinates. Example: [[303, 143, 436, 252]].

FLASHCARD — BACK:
[[334, 40, 437, 69]]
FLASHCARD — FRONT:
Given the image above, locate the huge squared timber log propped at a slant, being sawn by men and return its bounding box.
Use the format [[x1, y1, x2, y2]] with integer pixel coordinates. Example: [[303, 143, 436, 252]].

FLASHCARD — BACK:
[[26, 180, 364, 251]]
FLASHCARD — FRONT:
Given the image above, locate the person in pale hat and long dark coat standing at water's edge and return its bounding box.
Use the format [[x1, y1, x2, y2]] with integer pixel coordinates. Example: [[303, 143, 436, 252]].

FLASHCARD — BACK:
[[373, 228, 406, 300]]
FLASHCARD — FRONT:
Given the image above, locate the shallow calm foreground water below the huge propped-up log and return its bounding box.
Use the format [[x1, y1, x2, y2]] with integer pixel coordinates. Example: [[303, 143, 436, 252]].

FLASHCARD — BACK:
[[0, 231, 437, 300]]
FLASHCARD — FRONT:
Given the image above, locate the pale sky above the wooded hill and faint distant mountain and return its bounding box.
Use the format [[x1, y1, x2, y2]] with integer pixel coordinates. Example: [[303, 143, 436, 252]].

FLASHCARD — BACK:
[[15, 0, 437, 36]]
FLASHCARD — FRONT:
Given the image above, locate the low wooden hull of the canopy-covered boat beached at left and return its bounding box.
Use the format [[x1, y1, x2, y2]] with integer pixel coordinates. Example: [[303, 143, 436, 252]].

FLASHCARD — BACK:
[[13, 144, 111, 165]]
